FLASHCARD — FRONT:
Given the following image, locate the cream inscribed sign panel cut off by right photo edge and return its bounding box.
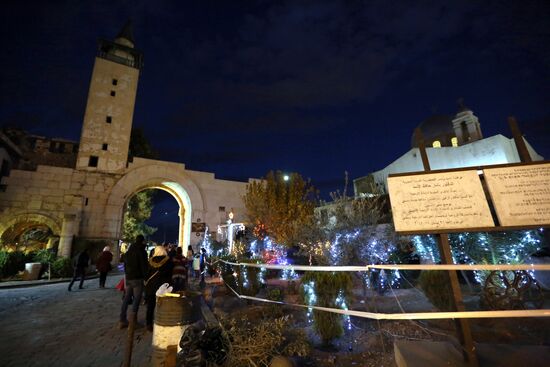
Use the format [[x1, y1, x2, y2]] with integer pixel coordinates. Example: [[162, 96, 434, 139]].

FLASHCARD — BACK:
[[483, 163, 550, 227]]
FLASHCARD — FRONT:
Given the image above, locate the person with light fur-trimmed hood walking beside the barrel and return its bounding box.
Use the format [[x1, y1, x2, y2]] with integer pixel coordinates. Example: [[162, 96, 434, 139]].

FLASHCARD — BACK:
[[145, 246, 174, 331]]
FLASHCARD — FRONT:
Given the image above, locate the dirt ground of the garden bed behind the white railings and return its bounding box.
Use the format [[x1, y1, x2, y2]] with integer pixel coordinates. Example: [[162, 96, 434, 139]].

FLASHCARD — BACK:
[[209, 280, 550, 367]]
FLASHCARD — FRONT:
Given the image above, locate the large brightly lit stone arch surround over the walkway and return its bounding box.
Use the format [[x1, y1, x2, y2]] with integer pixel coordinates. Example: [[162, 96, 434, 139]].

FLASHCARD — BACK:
[[106, 162, 204, 248]]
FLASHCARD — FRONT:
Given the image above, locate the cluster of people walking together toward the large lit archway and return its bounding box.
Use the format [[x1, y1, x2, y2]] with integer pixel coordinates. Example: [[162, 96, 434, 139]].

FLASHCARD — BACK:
[[118, 235, 206, 331]]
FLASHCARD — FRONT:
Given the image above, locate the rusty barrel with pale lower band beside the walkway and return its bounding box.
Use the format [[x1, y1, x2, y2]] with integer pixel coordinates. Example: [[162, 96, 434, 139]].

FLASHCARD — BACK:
[[151, 291, 201, 367]]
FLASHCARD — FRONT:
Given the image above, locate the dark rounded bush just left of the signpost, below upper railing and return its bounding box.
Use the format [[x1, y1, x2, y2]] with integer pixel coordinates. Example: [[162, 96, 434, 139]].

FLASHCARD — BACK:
[[418, 270, 454, 312]]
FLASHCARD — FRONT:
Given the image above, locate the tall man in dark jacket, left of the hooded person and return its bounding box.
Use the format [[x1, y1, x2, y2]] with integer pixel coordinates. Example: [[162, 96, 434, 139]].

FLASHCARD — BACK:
[[118, 235, 148, 329]]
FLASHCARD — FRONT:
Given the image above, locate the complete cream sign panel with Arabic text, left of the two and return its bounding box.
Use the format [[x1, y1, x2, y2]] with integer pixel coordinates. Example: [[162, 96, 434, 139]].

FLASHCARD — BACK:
[[388, 170, 495, 232]]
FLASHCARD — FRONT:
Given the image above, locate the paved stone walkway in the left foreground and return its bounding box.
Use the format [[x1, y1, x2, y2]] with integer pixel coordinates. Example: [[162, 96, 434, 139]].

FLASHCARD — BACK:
[[0, 275, 152, 367]]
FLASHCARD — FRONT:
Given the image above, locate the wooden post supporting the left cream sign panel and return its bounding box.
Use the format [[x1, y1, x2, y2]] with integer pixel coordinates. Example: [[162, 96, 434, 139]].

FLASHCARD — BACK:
[[414, 128, 479, 367]]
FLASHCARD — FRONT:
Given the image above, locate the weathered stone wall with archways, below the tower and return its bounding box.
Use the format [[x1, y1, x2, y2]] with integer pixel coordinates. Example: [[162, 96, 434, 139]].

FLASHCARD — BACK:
[[0, 158, 250, 256]]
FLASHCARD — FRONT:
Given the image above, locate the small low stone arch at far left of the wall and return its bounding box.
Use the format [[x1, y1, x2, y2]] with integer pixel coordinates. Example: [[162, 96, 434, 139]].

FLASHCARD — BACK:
[[0, 212, 61, 253]]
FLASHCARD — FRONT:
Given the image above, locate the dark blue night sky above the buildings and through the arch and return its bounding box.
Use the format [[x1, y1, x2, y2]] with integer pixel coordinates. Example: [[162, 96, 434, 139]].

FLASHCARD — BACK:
[[0, 0, 550, 244]]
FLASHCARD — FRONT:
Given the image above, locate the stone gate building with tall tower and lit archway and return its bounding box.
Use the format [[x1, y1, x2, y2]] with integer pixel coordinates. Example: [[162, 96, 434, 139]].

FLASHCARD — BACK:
[[0, 25, 254, 256]]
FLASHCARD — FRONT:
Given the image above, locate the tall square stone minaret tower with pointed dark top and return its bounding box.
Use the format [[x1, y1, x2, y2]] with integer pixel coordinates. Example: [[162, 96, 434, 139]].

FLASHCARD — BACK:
[[76, 22, 143, 173]]
